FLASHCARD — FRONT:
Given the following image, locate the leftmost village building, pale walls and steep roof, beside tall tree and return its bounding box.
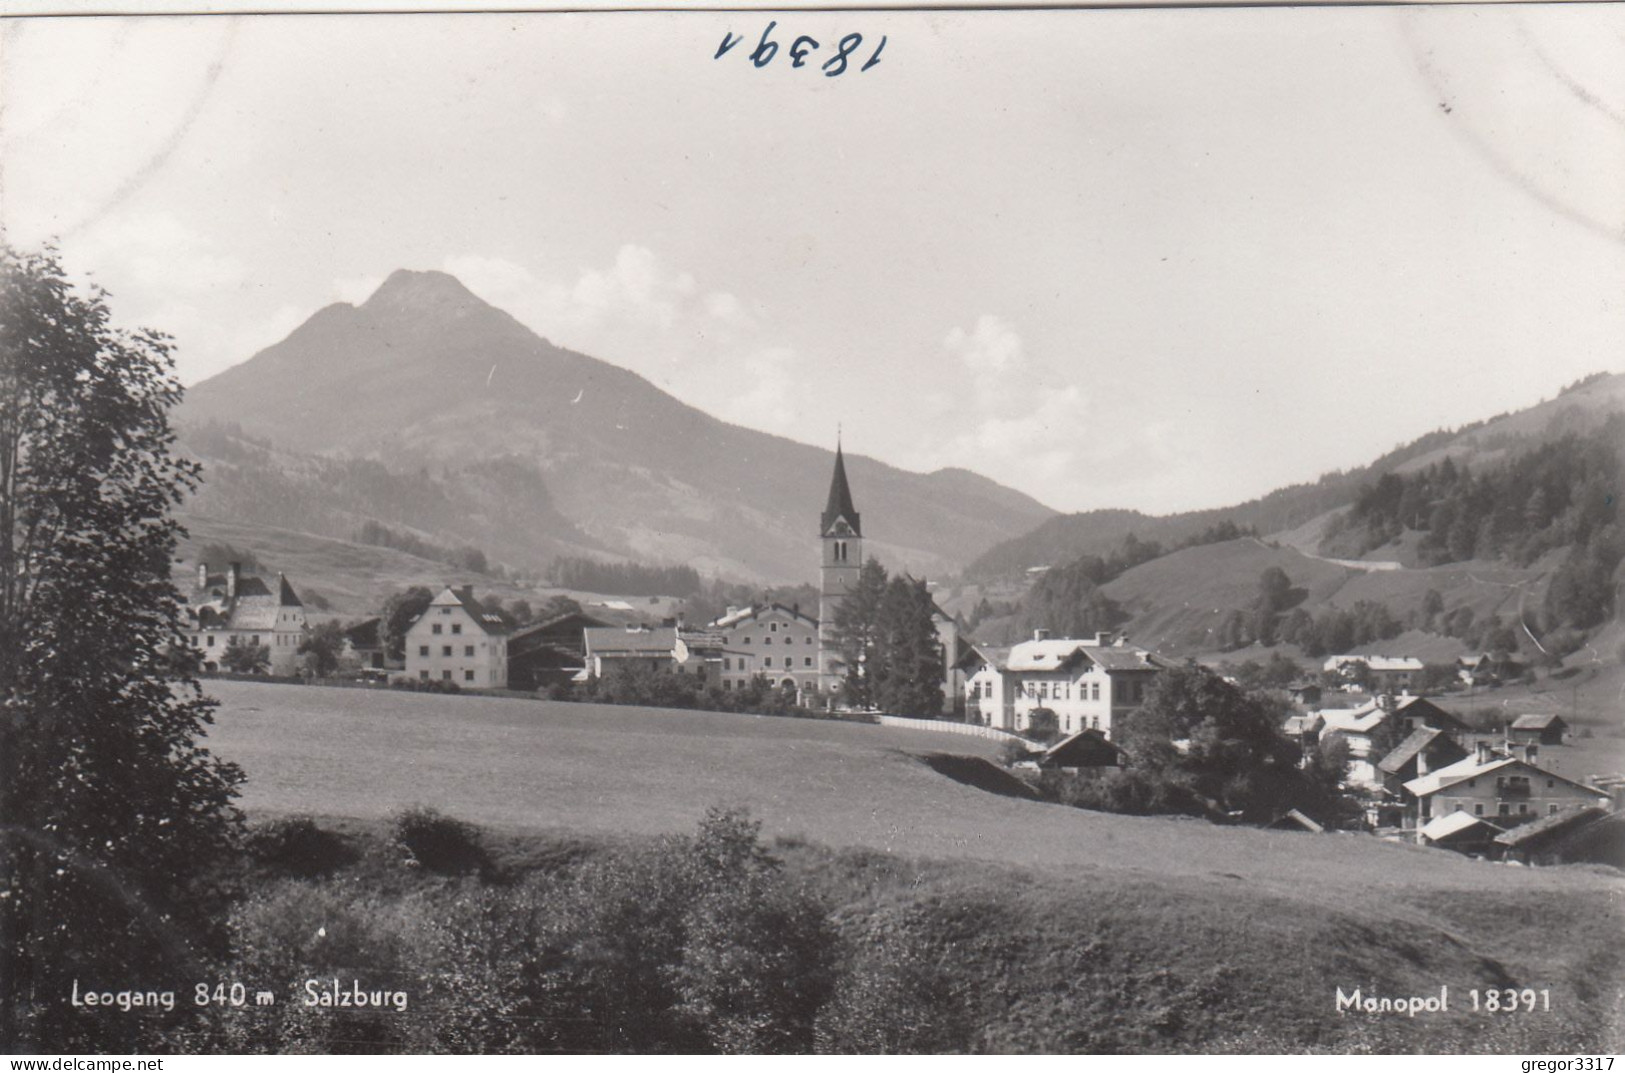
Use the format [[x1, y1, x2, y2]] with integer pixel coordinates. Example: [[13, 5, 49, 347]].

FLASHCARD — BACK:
[[185, 563, 306, 675]]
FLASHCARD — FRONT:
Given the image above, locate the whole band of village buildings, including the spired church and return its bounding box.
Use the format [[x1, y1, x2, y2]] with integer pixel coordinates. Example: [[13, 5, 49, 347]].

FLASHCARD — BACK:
[[187, 447, 1617, 860]]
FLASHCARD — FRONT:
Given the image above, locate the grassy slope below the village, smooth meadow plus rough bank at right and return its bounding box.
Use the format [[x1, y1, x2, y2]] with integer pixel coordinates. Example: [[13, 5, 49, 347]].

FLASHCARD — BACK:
[[210, 683, 1625, 1053]]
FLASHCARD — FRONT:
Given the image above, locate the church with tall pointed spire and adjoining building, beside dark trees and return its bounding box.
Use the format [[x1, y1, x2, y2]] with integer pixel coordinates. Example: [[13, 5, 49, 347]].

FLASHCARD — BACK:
[[709, 444, 964, 709]]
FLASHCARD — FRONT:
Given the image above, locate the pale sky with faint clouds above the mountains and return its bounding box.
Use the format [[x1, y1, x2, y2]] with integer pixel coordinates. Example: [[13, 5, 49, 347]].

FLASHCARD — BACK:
[[0, 5, 1625, 514]]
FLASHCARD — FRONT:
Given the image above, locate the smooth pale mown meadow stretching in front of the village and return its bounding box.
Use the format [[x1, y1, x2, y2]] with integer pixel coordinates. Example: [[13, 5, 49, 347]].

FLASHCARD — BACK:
[[208, 681, 1612, 896]]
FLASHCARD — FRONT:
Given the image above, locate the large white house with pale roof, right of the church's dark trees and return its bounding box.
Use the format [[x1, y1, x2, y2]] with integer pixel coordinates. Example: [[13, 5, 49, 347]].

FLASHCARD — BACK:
[[962, 629, 1167, 738]]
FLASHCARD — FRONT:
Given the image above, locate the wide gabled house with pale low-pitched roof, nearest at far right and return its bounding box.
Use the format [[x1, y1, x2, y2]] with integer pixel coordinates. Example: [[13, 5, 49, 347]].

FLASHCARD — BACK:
[[1404, 741, 1609, 828]]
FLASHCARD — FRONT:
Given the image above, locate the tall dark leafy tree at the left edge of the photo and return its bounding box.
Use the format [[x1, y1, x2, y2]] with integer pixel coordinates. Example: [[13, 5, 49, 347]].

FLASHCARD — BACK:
[[0, 244, 241, 1053]]
